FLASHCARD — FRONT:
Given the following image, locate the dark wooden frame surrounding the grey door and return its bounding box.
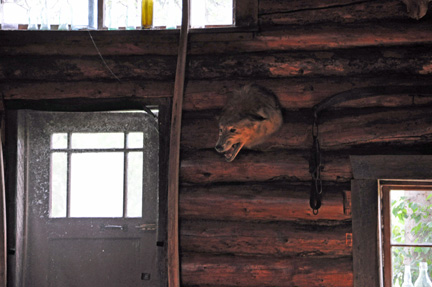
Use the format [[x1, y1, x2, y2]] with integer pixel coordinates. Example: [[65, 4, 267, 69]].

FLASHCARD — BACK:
[[5, 98, 172, 286]]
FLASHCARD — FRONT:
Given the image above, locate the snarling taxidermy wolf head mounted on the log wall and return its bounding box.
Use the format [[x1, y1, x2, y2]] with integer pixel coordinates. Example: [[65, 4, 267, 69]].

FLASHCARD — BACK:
[[215, 85, 283, 162]]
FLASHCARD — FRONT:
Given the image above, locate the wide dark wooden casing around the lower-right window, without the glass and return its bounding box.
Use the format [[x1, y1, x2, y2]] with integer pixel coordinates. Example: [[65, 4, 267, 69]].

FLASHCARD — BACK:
[[350, 155, 432, 287]]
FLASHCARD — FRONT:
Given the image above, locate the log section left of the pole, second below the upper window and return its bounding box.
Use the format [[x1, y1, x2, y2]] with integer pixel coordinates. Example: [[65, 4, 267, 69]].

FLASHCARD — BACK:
[[0, 56, 176, 81]]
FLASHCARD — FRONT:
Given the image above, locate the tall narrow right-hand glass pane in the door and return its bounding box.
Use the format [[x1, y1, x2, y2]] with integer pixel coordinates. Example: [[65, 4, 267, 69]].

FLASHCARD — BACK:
[[126, 152, 143, 217]]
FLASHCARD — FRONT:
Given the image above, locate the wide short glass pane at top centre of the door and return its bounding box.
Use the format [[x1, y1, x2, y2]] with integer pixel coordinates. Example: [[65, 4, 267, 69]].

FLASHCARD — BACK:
[[71, 133, 124, 149]]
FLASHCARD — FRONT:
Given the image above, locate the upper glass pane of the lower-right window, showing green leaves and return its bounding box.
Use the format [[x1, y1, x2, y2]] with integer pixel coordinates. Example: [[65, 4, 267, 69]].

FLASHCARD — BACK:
[[390, 190, 432, 244]]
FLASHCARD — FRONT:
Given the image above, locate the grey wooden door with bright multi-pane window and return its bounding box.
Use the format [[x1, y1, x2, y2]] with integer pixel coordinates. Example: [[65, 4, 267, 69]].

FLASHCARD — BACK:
[[21, 112, 159, 287]]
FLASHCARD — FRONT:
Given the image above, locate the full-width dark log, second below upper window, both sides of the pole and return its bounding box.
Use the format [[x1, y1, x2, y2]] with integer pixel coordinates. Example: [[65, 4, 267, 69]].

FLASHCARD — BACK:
[[0, 46, 432, 81]]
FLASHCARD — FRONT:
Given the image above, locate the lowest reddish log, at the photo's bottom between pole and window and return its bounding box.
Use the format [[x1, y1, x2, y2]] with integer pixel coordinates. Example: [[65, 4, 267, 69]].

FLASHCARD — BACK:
[[181, 254, 353, 287]]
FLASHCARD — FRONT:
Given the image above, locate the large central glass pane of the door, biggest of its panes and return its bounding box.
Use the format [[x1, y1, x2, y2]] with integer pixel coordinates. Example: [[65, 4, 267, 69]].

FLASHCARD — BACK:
[[70, 152, 124, 217]]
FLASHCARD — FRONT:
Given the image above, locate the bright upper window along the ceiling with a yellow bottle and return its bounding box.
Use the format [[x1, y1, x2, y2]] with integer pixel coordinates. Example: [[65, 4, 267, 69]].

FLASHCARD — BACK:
[[0, 0, 235, 30]]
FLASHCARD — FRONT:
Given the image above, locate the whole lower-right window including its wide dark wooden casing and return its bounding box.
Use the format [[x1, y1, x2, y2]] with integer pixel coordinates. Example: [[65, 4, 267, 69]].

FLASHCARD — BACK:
[[350, 158, 432, 287]]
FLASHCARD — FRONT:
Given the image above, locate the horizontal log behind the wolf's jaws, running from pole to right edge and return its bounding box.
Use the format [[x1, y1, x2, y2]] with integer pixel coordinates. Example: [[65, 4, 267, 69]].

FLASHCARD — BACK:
[[181, 106, 432, 151]]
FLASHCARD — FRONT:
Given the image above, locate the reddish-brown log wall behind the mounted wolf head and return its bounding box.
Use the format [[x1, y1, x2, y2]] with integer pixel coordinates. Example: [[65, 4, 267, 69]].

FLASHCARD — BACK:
[[0, 0, 432, 287]]
